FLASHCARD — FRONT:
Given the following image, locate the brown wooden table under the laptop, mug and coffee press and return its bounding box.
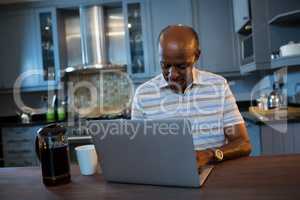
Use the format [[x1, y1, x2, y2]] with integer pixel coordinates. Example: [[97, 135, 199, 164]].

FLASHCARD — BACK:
[[0, 155, 300, 200]]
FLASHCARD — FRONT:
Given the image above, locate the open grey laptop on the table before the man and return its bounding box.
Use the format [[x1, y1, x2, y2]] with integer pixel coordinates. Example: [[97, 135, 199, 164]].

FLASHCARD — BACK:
[[89, 119, 213, 187]]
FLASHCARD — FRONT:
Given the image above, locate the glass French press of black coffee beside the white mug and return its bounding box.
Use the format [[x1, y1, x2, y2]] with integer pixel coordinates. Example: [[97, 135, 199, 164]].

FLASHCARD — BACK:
[[36, 124, 71, 186]]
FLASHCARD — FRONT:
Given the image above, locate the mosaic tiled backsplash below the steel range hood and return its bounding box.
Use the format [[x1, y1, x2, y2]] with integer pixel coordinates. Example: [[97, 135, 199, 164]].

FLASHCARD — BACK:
[[68, 70, 133, 117]]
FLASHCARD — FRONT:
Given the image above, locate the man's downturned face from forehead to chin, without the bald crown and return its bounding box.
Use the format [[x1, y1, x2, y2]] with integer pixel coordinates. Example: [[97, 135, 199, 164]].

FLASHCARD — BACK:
[[160, 48, 198, 92]]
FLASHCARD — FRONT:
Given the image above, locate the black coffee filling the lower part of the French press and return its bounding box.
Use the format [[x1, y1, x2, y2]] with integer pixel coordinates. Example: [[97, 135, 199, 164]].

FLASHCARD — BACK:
[[40, 145, 71, 186]]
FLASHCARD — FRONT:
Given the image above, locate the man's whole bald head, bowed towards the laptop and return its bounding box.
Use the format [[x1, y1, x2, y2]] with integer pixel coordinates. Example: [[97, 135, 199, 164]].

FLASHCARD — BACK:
[[159, 26, 200, 93]]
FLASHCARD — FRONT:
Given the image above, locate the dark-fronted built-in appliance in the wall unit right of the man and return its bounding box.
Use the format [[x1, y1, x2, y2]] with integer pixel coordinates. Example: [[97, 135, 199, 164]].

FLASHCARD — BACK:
[[241, 34, 254, 65]]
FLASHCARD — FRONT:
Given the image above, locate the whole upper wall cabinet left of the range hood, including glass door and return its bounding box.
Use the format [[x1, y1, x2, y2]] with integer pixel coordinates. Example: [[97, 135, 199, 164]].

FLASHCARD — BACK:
[[0, 9, 59, 90]]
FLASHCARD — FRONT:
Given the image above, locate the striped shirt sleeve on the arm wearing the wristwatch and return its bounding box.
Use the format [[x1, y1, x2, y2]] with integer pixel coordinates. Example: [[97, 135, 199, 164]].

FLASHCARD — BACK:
[[223, 82, 244, 127]]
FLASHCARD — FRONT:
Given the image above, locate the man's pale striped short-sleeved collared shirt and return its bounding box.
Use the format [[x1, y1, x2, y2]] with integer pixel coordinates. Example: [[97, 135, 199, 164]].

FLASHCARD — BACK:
[[131, 68, 244, 150]]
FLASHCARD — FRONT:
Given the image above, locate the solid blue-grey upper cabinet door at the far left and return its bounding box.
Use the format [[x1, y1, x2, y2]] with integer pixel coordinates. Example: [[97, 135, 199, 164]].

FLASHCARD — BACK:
[[0, 10, 39, 89]]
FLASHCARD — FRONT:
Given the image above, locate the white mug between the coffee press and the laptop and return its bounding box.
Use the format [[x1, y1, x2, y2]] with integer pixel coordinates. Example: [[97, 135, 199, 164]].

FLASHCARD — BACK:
[[75, 144, 98, 175]]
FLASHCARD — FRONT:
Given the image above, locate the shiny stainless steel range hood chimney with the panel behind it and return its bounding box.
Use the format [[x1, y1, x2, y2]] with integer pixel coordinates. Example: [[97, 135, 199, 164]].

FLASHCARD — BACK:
[[63, 6, 126, 73]]
